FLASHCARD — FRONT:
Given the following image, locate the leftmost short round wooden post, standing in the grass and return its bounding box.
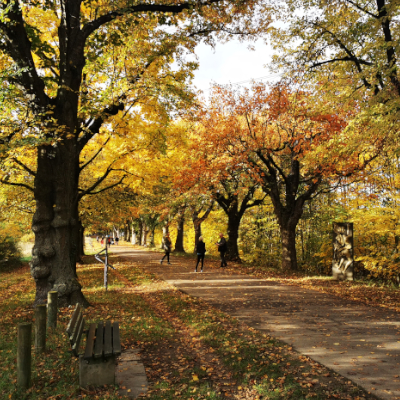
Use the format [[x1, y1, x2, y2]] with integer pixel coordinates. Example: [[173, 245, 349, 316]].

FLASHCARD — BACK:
[[17, 323, 32, 390]]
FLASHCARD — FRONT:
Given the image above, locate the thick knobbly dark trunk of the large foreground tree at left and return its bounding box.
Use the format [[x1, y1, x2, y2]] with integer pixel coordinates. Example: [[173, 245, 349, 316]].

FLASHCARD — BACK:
[[31, 140, 88, 306]]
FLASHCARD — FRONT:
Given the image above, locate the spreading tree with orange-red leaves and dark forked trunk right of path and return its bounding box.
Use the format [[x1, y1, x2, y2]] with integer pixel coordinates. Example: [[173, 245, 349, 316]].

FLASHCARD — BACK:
[[198, 83, 380, 270]]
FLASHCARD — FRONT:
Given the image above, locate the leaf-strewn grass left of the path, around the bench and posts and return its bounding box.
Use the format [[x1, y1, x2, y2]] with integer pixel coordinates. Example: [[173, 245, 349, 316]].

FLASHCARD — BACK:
[[0, 256, 374, 400]]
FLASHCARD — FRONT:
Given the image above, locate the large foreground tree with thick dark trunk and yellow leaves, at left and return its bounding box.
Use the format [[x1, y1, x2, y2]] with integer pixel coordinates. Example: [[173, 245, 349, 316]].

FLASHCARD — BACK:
[[0, 0, 266, 304]]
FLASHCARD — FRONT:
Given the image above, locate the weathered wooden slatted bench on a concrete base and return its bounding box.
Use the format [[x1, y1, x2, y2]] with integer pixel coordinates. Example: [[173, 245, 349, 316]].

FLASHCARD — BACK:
[[67, 304, 121, 387]]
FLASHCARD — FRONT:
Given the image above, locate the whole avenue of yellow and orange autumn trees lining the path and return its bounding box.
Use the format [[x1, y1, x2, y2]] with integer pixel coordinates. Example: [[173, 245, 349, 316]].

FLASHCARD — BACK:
[[0, 0, 400, 304]]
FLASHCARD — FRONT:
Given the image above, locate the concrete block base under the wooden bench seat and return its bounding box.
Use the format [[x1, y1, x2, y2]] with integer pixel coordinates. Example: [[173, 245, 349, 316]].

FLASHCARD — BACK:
[[79, 356, 116, 388]]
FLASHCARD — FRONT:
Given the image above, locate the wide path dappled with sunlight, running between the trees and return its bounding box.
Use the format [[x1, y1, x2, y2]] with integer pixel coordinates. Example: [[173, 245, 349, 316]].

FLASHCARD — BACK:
[[112, 246, 400, 400]]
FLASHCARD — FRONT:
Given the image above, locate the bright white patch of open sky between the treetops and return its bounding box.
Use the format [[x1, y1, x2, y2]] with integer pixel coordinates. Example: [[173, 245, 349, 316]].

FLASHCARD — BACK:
[[193, 40, 282, 96]]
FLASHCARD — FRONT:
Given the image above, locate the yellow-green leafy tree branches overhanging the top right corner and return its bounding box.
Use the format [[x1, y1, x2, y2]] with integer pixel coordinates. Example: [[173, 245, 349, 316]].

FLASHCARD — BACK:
[[273, 0, 400, 126]]
